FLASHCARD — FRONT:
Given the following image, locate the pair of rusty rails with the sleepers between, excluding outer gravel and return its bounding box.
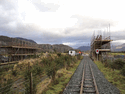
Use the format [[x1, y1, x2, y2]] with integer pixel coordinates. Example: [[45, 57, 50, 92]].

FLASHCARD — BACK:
[[80, 63, 99, 94]]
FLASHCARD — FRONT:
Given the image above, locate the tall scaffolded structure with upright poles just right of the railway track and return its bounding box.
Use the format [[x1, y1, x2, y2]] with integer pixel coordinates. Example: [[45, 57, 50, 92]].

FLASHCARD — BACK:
[[90, 27, 113, 61]]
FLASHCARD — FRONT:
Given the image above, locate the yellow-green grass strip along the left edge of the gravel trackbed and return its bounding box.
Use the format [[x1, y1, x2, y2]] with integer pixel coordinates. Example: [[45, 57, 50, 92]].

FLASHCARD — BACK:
[[42, 60, 80, 94]]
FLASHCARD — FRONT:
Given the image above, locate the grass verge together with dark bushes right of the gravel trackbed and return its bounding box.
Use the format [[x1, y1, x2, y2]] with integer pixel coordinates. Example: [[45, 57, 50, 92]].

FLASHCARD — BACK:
[[95, 59, 125, 94]]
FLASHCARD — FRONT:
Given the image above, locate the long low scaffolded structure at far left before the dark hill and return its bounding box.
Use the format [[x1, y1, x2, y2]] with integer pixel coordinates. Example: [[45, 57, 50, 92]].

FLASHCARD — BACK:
[[0, 37, 39, 62]]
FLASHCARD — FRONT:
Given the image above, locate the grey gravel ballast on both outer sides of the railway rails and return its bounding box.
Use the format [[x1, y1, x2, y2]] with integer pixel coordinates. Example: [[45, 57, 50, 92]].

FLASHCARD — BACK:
[[63, 56, 120, 94]]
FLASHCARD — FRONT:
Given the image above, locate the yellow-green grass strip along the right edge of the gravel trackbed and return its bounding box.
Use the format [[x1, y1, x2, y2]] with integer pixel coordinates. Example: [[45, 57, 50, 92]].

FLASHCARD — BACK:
[[95, 61, 125, 94]]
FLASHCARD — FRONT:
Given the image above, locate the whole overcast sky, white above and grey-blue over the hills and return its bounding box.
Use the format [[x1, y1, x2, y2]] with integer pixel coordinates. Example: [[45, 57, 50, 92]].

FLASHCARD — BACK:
[[0, 0, 125, 48]]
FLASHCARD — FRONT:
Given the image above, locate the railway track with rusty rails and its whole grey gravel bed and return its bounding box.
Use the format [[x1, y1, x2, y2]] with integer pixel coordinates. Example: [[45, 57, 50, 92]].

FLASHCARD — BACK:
[[63, 56, 120, 94]]
